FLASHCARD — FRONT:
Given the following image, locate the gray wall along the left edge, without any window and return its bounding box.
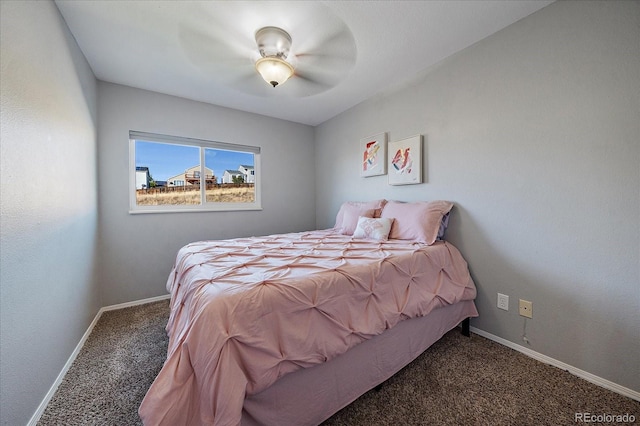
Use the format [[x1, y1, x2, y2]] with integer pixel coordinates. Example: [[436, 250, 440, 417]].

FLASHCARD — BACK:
[[0, 1, 100, 425]]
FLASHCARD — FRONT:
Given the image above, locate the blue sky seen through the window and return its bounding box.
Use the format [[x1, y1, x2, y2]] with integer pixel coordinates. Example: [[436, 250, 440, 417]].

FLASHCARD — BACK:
[[136, 141, 253, 181]]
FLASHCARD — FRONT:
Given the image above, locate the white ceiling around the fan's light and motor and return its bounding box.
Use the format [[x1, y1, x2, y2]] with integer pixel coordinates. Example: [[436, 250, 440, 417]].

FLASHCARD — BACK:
[[56, 0, 552, 125]]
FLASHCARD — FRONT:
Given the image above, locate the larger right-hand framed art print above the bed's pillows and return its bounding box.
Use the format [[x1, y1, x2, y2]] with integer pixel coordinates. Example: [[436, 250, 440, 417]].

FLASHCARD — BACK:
[[389, 135, 422, 185]]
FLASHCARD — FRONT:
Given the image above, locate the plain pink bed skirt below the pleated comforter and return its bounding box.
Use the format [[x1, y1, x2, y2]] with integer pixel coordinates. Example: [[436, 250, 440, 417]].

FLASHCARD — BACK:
[[242, 300, 478, 426]]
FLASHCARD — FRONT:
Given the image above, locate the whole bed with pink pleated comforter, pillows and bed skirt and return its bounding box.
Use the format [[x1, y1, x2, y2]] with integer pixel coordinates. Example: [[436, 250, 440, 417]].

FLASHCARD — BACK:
[[139, 200, 478, 426]]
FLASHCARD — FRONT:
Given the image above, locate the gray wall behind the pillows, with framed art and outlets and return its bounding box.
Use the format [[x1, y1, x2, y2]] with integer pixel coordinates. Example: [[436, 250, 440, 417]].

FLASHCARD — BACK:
[[316, 1, 640, 391]]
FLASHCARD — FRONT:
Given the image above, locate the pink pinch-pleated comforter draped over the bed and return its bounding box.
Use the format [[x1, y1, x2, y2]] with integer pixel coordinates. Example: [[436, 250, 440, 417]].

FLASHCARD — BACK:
[[139, 230, 476, 426]]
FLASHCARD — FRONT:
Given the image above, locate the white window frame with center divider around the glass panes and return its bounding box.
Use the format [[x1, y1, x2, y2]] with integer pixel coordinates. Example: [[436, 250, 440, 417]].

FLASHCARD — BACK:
[[129, 130, 262, 214]]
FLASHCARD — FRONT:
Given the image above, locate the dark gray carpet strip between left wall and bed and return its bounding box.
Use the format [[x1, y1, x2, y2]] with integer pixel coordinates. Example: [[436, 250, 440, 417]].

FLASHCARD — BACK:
[[38, 301, 169, 426]]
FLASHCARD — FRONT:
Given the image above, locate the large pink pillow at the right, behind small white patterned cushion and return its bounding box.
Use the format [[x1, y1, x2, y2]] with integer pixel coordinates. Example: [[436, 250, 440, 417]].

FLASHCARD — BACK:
[[381, 201, 453, 245]]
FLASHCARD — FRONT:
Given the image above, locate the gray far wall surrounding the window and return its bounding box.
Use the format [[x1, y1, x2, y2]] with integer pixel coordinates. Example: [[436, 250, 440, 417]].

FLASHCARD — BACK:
[[98, 82, 315, 305]]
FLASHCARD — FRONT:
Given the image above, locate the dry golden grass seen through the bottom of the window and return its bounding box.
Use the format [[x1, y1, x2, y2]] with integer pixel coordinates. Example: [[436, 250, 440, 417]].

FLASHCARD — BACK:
[[136, 186, 255, 206]]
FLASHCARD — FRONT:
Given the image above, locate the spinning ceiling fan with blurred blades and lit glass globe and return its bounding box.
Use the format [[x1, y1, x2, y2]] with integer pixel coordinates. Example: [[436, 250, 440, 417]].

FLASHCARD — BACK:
[[180, 2, 357, 97]]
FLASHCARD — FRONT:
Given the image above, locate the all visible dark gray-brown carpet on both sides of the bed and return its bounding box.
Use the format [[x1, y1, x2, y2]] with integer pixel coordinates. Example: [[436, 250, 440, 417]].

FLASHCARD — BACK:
[[38, 301, 640, 426]]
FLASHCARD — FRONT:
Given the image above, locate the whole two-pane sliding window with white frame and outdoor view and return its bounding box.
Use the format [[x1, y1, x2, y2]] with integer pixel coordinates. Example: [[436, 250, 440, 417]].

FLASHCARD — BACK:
[[129, 131, 261, 213]]
